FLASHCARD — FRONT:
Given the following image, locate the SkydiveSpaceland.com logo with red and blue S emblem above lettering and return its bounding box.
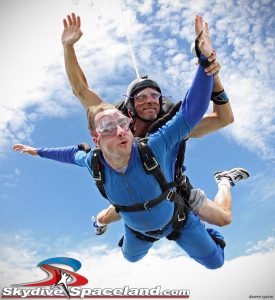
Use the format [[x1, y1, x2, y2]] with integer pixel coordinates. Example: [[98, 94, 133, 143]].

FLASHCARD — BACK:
[[1, 257, 190, 299]]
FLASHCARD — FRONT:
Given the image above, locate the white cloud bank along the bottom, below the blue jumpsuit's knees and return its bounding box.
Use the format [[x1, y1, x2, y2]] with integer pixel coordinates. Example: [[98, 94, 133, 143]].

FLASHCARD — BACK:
[[0, 236, 275, 300]]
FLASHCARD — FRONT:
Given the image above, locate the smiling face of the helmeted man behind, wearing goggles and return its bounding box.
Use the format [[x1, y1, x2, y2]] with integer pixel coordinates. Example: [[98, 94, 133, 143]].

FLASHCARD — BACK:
[[134, 87, 160, 121]]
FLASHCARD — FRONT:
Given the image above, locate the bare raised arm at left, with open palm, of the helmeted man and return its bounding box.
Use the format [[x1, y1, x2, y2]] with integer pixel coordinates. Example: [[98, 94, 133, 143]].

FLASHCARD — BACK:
[[61, 13, 102, 109]]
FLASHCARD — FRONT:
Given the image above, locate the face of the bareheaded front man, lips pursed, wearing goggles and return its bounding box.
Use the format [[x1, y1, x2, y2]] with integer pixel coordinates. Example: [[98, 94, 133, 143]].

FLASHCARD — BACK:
[[93, 109, 134, 162]]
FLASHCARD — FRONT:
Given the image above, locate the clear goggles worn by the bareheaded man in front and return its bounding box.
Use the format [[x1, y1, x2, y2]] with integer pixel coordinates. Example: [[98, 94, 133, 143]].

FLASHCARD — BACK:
[[92, 113, 133, 136]]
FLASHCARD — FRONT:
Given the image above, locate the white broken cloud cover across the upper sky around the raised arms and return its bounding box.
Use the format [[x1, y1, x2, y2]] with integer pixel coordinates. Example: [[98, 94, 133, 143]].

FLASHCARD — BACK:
[[0, 0, 275, 159]]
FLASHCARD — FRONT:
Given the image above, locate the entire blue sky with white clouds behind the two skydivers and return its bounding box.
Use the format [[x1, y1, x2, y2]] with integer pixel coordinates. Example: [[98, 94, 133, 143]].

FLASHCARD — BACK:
[[0, 0, 275, 299]]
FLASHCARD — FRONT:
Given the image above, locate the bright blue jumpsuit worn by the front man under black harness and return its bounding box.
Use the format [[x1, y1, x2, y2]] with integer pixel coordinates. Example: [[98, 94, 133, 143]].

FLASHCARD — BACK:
[[38, 66, 224, 269]]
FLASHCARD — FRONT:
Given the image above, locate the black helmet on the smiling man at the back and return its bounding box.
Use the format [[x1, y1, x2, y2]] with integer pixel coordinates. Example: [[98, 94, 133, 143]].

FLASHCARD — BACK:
[[125, 75, 162, 116]]
